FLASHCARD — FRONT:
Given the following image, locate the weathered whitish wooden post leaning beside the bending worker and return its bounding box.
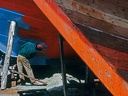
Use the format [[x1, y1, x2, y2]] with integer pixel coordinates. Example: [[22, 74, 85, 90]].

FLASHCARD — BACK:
[[1, 21, 16, 90]]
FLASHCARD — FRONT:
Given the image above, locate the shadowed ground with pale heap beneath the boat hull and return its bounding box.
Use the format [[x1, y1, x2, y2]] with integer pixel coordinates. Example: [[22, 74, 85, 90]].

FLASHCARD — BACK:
[[0, 66, 112, 96]]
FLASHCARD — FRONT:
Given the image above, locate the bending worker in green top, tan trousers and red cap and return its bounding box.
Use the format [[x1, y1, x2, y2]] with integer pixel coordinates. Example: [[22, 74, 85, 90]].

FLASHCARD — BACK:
[[17, 42, 43, 85]]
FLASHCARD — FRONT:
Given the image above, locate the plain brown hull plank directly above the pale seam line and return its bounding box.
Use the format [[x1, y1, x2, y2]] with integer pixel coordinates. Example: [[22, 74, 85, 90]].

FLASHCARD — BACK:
[[62, 8, 128, 38]]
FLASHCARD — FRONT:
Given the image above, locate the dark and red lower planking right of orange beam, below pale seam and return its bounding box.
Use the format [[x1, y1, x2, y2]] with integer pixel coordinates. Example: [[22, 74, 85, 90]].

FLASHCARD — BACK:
[[77, 25, 128, 70]]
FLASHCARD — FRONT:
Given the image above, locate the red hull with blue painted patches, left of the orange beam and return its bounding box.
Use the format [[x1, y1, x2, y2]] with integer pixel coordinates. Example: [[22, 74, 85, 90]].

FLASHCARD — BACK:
[[0, 0, 75, 65]]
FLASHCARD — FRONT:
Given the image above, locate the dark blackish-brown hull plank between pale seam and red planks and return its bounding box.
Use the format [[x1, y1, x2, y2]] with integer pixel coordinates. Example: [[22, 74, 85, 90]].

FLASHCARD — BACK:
[[76, 24, 128, 53]]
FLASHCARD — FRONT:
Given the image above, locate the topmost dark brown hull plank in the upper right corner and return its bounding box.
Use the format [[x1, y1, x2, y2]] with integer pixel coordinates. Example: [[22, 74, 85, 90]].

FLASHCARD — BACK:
[[74, 0, 128, 19]]
